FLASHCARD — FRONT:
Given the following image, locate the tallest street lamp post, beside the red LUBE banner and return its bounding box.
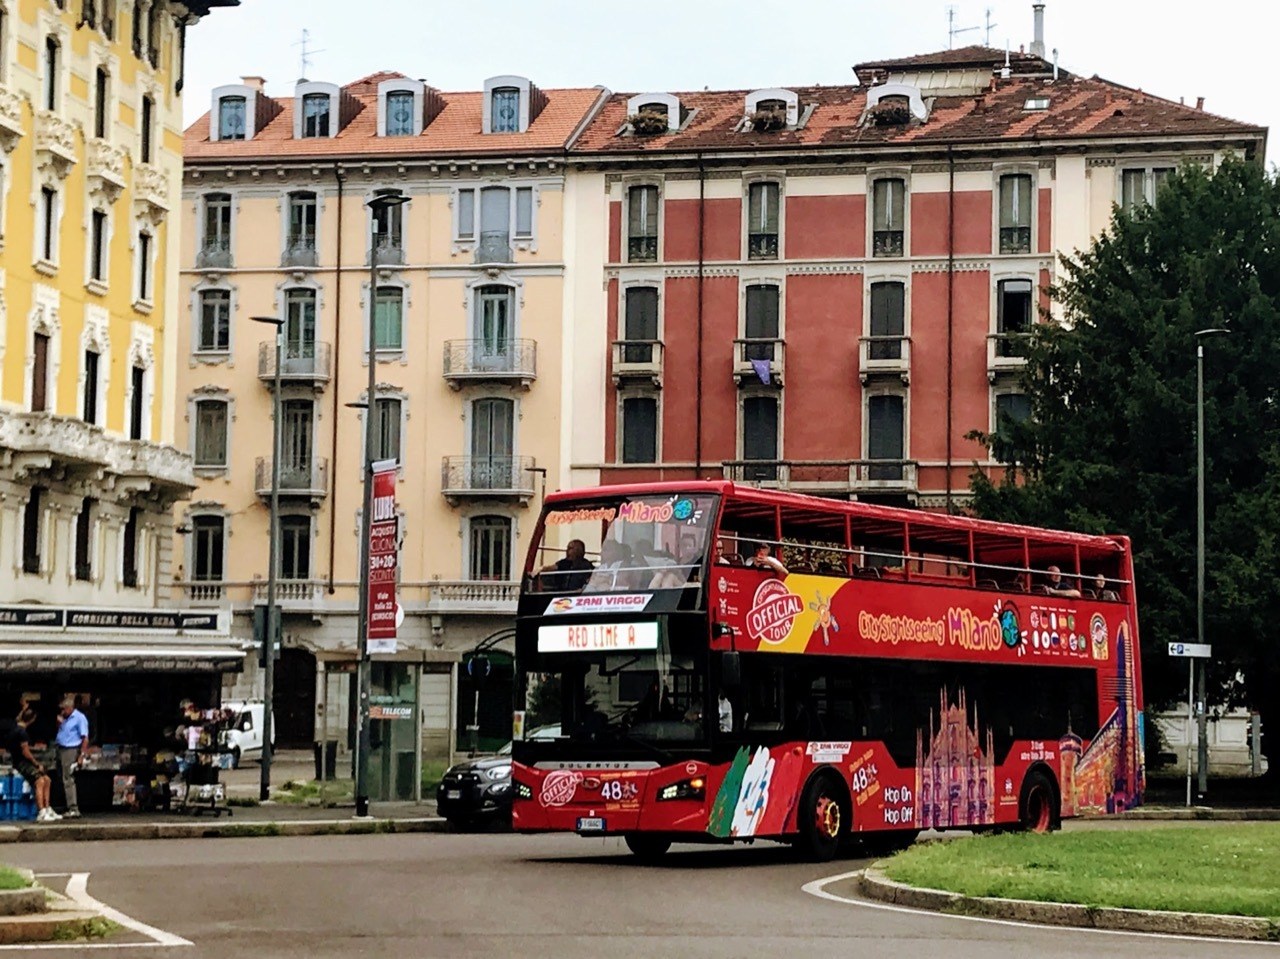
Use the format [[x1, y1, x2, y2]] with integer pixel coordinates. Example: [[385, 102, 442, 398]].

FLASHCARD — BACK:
[[356, 189, 408, 817]]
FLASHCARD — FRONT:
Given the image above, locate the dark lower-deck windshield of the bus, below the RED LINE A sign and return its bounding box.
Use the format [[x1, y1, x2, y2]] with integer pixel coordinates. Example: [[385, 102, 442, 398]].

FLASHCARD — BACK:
[[525, 629, 707, 749]]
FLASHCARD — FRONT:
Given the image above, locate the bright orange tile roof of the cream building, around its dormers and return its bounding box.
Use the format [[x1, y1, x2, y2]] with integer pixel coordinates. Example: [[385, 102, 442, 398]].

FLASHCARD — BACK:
[[183, 72, 604, 161]]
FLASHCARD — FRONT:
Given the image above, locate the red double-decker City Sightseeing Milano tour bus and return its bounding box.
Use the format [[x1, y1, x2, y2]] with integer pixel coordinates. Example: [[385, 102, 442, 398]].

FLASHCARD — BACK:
[[513, 481, 1143, 859]]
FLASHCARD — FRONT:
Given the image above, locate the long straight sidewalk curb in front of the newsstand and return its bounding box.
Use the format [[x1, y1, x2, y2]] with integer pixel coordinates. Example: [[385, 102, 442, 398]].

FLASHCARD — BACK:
[[0, 817, 448, 844]]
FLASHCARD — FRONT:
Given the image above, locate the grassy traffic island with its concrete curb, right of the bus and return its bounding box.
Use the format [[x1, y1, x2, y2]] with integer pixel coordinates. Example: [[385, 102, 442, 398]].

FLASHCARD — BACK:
[[860, 823, 1280, 941]]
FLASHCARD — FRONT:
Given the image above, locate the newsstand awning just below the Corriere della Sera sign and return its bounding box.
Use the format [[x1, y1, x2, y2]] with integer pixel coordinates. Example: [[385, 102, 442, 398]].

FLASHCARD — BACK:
[[0, 643, 244, 673]]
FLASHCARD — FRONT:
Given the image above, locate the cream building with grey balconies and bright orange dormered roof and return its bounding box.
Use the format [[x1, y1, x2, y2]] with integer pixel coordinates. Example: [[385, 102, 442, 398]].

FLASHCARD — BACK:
[[175, 73, 603, 776]]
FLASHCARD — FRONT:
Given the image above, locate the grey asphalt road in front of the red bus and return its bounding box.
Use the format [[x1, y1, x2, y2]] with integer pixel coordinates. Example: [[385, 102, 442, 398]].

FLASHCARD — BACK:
[[4, 834, 1280, 959]]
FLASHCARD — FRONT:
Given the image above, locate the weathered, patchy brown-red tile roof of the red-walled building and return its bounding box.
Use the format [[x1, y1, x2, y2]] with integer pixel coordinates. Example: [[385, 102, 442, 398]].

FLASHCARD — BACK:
[[573, 73, 1266, 154]]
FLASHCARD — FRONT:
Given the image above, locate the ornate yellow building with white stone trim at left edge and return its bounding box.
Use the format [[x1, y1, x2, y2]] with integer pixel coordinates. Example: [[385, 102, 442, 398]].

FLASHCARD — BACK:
[[0, 0, 237, 741]]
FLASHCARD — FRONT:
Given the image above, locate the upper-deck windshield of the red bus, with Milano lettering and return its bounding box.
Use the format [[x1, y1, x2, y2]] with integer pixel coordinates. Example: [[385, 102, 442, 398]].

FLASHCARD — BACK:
[[526, 493, 718, 593]]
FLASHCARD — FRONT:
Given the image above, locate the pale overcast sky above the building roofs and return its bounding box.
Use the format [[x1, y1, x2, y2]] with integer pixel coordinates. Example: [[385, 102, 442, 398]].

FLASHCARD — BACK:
[[186, 0, 1280, 163]]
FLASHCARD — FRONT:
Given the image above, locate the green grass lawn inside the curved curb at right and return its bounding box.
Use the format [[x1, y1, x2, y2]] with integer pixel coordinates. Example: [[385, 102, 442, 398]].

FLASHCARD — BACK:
[[884, 822, 1280, 921]]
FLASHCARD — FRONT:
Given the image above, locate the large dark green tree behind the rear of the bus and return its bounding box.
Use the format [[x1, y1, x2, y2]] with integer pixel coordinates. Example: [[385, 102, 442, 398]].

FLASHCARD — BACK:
[[973, 159, 1280, 777]]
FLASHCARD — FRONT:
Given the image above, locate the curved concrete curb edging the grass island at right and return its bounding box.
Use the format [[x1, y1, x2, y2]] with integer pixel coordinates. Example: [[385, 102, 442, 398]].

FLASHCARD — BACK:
[[859, 863, 1280, 941]]
